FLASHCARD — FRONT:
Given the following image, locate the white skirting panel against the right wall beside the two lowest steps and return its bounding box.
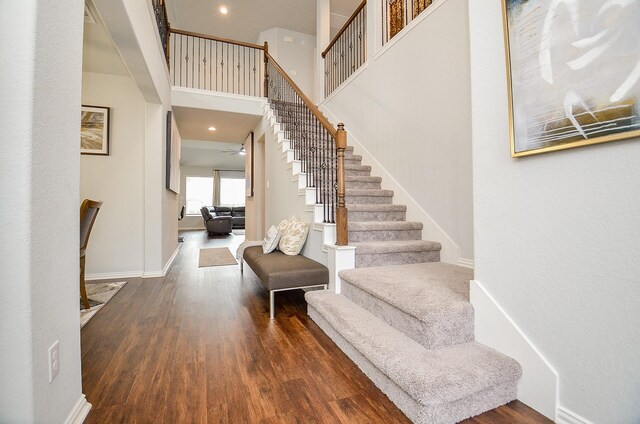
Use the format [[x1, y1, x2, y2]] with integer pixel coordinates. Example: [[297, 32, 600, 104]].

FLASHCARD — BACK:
[[470, 280, 559, 420]]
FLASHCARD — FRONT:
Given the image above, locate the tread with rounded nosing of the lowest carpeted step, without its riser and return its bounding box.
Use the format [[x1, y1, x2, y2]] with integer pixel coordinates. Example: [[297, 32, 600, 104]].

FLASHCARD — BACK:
[[305, 290, 521, 405]]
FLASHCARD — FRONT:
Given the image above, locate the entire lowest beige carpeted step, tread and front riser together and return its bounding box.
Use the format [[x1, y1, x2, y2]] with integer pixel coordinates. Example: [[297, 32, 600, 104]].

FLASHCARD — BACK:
[[305, 291, 521, 424]]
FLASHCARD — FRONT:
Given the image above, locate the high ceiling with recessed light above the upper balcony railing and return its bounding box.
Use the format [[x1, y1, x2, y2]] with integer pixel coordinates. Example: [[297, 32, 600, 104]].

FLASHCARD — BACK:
[[167, 0, 360, 43]]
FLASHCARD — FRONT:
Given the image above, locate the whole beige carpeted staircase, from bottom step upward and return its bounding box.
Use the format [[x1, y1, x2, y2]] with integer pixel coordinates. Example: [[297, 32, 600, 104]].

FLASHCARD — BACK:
[[264, 102, 521, 423]]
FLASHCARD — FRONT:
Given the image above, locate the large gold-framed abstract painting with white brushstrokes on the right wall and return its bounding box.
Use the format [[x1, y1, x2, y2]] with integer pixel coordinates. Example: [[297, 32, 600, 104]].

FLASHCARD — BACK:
[[503, 0, 640, 157]]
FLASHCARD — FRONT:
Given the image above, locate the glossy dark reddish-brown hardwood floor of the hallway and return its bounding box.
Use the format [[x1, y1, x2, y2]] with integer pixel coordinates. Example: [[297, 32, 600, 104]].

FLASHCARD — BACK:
[[82, 231, 551, 424]]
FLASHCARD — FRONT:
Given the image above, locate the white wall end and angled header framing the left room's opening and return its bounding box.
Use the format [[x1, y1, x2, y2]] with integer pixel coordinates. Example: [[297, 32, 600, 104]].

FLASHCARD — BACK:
[[94, 0, 178, 277]]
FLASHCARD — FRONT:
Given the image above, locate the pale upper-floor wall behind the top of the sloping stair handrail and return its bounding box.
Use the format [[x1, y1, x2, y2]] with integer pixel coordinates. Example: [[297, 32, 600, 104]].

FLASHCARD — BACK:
[[258, 28, 316, 101]]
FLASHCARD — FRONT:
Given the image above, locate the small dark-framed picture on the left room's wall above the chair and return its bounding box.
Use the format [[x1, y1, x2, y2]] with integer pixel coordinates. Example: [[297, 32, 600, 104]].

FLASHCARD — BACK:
[[80, 105, 110, 156]]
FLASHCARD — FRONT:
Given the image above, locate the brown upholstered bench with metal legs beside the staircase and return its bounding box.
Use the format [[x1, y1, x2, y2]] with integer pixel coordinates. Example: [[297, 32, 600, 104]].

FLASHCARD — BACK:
[[240, 246, 329, 319]]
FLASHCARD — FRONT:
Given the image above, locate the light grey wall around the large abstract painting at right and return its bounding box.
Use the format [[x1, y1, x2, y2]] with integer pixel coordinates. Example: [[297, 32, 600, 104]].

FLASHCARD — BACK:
[[469, 0, 640, 424]]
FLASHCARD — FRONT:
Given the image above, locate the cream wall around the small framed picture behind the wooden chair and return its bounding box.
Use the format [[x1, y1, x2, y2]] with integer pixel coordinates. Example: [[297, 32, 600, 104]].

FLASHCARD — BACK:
[[80, 72, 145, 278]]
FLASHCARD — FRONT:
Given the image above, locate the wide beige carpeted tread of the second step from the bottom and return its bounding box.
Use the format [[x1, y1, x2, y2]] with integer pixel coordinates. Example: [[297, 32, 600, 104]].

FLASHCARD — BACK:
[[338, 262, 473, 322]]
